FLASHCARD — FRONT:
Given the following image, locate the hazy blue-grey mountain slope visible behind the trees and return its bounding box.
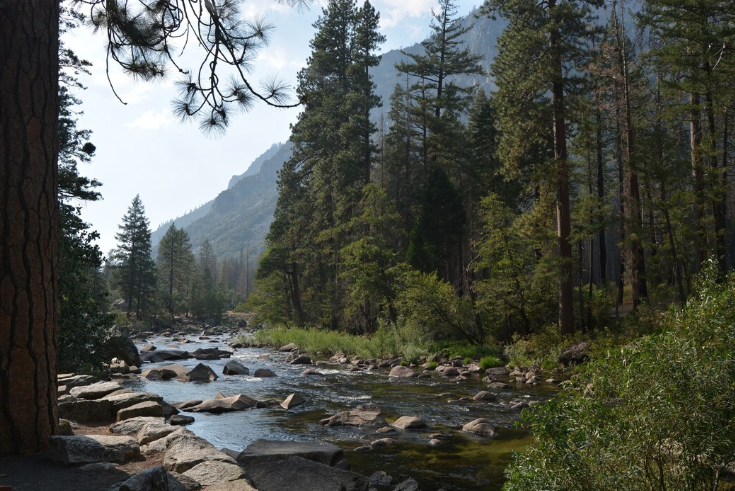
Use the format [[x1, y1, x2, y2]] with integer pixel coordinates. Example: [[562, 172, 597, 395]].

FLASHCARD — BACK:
[[151, 7, 505, 257]]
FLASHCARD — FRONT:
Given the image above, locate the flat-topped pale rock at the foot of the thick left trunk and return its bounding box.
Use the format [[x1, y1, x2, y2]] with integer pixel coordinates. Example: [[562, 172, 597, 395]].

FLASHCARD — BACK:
[[46, 435, 140, 465]]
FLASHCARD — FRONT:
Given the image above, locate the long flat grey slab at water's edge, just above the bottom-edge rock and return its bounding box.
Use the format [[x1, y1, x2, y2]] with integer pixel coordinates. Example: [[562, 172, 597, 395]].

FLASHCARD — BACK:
[[237, 440, 344, 468]]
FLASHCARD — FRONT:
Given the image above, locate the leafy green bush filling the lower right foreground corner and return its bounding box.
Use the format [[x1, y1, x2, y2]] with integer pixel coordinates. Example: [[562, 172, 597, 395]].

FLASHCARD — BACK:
[[505, 267, 735, 491]]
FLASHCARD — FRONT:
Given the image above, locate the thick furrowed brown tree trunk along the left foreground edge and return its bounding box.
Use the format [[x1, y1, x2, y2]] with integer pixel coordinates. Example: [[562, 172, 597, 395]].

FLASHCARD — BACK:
[[0, 0, 59, 455]]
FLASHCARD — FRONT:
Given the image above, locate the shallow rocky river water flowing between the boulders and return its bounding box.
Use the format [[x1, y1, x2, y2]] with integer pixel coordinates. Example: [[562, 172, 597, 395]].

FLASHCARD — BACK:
[[125, 336, 554, 491]]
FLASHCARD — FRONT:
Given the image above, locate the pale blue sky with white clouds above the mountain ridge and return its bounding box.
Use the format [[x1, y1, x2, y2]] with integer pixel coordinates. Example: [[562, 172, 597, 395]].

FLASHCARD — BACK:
[[63, 0, 481, 254]]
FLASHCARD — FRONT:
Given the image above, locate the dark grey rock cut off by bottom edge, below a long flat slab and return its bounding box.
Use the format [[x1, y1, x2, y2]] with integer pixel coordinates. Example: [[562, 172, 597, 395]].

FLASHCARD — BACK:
[[246, 457, 370, 491]]
